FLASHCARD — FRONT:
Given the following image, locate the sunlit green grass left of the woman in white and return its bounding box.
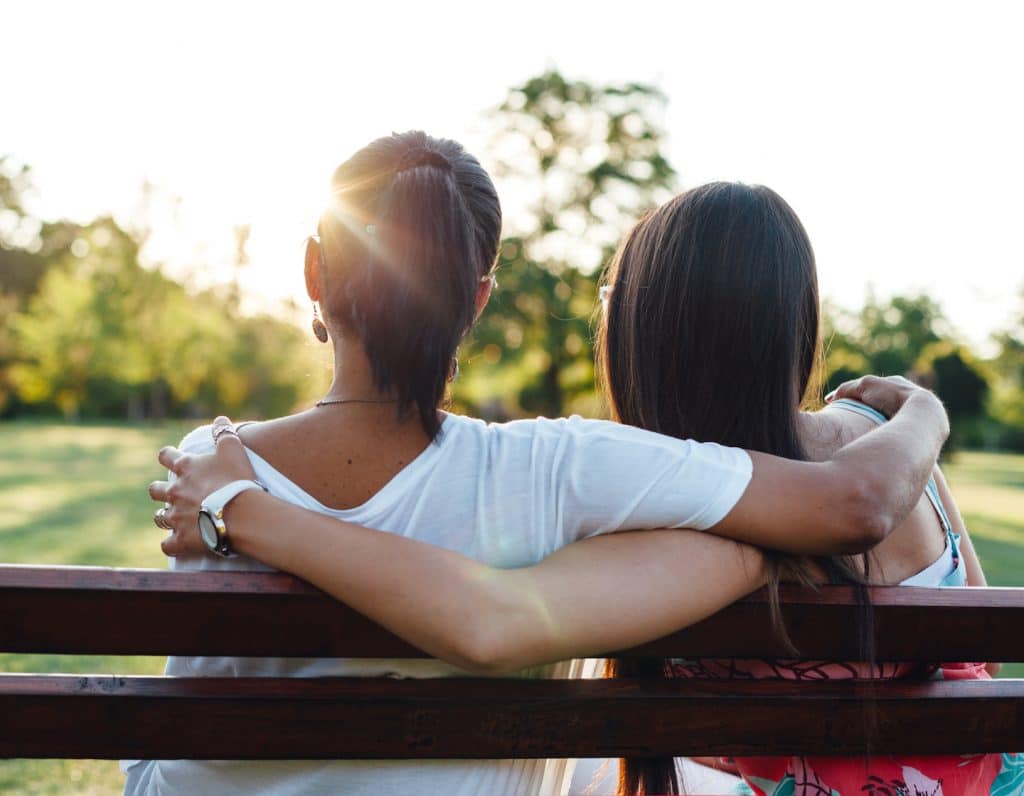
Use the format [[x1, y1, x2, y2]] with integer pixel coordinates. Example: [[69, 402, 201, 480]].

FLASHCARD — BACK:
[[0, 423, 185, 796]]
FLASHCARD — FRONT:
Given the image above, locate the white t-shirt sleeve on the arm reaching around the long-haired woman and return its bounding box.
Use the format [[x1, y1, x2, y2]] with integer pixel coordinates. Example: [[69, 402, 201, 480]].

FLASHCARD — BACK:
[[551, 417, 753, 544]]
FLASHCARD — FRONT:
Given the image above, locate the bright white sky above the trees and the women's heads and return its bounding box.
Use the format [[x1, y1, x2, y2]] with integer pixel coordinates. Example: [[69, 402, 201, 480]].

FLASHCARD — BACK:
[[0, 0, 1024, 343]]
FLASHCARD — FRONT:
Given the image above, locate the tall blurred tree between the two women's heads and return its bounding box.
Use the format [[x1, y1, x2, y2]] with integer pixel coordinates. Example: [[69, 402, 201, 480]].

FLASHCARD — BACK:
[[459, 71, 675, 415]]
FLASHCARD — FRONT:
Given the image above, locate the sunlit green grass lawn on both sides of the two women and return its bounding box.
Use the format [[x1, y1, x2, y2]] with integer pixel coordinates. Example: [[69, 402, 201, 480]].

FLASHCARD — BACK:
[[0, 423, 1024, 794]]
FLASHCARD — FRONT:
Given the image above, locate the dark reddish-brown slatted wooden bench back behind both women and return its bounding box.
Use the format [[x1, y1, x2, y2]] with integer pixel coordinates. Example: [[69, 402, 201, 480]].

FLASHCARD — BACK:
[[0, 567, 1024, 759]]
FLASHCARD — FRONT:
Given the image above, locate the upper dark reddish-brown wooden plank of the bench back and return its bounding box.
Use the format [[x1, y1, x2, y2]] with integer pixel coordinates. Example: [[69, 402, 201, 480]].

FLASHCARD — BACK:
[[6, 565, 1024, 661]]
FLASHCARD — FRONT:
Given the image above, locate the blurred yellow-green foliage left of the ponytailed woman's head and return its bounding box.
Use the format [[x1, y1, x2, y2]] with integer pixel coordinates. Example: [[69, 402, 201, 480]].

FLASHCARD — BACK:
[[0, 164, 326, 419]]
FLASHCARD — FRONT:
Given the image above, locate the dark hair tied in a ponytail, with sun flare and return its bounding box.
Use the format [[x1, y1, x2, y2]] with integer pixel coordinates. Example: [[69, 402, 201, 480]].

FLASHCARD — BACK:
[[318, 131, 502, 438]]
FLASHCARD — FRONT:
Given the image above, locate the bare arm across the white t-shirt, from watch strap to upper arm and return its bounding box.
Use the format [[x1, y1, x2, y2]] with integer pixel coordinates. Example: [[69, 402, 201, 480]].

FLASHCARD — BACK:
[[225, 492, 764, 673]]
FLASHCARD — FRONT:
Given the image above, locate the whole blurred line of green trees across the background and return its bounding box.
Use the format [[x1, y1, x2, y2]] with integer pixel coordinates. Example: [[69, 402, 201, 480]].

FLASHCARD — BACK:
[[0, 71, 1024, 450]]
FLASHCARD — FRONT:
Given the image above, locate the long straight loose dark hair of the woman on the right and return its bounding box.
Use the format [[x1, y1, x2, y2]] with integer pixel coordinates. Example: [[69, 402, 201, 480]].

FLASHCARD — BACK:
[[598, 182, 870, 794]]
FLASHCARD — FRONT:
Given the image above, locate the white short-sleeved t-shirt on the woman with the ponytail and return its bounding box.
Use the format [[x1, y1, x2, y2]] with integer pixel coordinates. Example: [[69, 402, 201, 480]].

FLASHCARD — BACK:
[[126, 415, 752, 796]]
